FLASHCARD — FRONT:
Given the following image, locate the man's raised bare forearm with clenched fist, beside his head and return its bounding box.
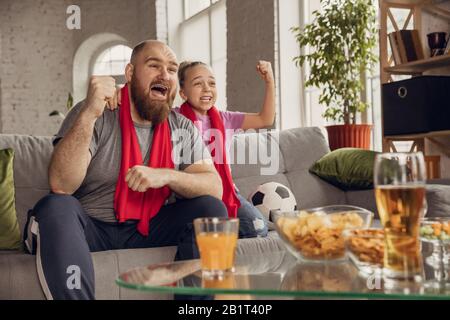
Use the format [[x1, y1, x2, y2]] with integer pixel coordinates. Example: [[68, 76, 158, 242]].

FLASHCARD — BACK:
[[48, 77, 115, 194]]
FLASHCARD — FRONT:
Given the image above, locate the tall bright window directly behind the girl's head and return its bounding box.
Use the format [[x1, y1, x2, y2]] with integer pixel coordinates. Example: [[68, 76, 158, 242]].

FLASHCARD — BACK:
[[168, 0, 227, 110]]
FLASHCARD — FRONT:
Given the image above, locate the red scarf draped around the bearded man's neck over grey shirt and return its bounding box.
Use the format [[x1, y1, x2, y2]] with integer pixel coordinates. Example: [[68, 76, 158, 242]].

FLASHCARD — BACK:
[[114, 85, 175, 236]]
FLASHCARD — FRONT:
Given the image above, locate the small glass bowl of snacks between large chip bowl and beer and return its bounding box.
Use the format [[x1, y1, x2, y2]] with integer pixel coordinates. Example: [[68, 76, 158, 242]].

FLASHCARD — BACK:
[[344, 228, 385, 275]]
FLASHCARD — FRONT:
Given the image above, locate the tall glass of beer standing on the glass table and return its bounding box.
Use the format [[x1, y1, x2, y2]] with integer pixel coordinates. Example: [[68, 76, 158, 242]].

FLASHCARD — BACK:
[[374, 152, 426, 285]]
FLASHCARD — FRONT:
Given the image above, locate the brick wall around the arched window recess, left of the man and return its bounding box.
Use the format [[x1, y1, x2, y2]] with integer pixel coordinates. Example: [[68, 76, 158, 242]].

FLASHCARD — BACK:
[[0, 0, 156, 135]]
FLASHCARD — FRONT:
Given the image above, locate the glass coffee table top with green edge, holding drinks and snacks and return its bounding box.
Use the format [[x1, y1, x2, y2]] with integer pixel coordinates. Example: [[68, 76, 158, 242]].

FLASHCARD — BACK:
[[116, 251, 450, 300]]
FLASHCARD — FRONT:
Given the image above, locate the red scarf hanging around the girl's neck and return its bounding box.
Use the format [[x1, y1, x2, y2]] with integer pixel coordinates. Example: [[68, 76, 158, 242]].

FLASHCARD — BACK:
[[180, 102, 241, 218]]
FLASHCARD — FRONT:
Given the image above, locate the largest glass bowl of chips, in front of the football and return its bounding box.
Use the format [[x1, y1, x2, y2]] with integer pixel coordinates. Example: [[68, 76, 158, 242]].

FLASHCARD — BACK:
[[272, 205, 374, 262]]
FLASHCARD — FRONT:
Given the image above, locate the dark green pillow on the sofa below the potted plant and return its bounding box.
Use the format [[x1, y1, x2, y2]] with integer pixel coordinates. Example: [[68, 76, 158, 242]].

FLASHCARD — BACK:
[[309, 148, 377, 190]]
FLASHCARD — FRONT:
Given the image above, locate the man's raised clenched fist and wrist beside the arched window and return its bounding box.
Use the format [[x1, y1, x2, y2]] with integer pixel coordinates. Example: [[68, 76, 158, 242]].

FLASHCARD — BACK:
[[84, 76, 117, 119]]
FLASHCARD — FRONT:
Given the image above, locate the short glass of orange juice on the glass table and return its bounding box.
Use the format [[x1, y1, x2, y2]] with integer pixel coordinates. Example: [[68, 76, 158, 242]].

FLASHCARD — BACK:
[[194, 218, 239, 277]]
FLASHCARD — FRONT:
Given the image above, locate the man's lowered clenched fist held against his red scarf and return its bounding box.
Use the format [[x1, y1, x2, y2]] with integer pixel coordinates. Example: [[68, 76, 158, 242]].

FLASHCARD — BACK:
[[125, 166, 170, 192]]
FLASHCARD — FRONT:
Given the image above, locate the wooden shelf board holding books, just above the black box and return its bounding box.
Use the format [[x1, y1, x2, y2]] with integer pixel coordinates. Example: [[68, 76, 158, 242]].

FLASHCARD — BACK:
[[384, 55, 450, 75]]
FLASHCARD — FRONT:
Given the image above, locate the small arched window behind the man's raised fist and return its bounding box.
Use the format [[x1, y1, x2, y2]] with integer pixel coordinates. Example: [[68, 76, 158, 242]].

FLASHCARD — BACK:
[[92, 45, 133, 84]]
